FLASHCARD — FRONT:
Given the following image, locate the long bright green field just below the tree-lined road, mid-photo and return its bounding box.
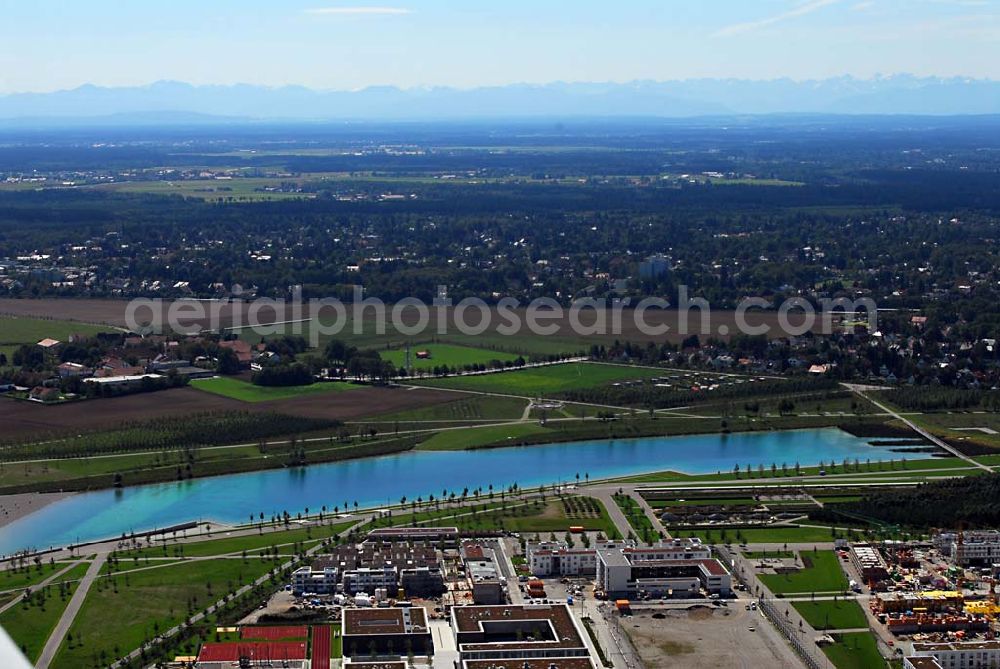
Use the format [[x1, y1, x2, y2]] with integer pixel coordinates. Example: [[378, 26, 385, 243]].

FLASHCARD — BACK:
[[410, 362, 664, 397]]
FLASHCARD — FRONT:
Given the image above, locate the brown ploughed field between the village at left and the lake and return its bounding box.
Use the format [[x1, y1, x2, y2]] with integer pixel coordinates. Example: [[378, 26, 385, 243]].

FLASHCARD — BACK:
[[0, 387, 459, 440]]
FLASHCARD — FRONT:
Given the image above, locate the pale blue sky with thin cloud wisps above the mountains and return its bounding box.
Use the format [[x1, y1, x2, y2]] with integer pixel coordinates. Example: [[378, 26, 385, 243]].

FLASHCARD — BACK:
[[0, 0, 1000, 92]]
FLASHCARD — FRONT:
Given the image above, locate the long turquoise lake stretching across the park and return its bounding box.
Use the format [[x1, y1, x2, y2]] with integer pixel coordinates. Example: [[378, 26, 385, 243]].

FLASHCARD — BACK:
[[0, 428, 912, 554]]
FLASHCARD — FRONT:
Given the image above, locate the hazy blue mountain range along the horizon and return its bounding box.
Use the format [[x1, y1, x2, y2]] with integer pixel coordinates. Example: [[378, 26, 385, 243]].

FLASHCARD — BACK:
[[0, 75, 1000, 123]]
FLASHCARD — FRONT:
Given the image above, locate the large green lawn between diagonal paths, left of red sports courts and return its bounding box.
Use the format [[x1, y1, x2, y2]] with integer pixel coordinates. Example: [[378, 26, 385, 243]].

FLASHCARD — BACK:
[[53, 560, 271, 667]]
